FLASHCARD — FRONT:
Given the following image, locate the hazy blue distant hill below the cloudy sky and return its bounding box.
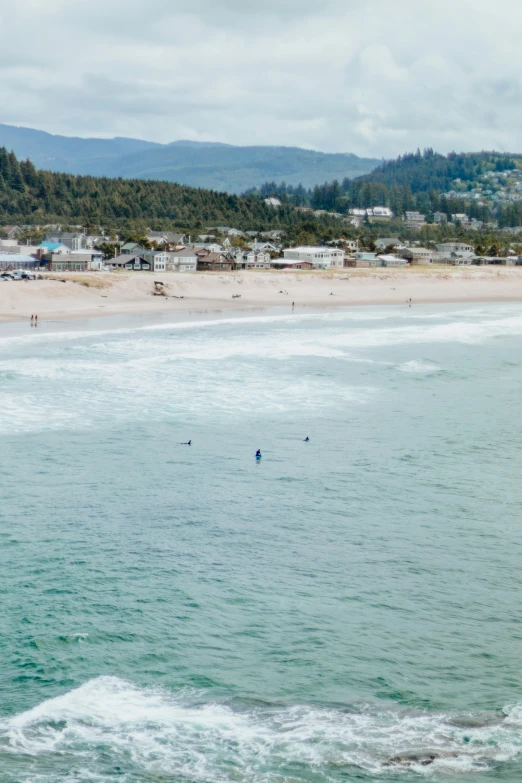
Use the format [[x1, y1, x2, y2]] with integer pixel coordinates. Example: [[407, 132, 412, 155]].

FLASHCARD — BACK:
[[0, 124, 380, 193]]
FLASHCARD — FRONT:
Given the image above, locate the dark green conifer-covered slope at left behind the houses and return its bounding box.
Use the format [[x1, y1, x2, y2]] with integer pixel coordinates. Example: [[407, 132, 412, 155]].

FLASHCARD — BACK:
[[0, 148, 316, 230]]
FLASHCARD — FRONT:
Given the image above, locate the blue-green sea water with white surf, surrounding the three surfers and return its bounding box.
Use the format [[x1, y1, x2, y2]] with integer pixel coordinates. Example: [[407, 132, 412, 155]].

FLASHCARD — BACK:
[[0, 304, 522, 783]]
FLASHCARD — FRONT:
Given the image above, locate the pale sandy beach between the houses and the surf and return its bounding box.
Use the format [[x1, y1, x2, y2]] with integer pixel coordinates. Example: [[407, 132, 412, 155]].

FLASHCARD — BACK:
[[0, 267, 522, 323]]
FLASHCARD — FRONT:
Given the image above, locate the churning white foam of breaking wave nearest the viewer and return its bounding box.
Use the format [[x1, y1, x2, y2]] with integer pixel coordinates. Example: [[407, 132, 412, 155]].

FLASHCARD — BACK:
[[0, 677, 522, 783]]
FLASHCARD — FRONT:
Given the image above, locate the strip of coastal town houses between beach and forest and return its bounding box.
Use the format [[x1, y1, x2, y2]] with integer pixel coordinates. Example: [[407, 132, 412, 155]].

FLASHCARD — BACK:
[[0, 220, 522, 280]]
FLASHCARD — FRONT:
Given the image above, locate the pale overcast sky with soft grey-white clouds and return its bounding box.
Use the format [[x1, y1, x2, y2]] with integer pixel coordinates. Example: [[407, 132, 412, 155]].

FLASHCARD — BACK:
[[0, 0, 522, 157]]
